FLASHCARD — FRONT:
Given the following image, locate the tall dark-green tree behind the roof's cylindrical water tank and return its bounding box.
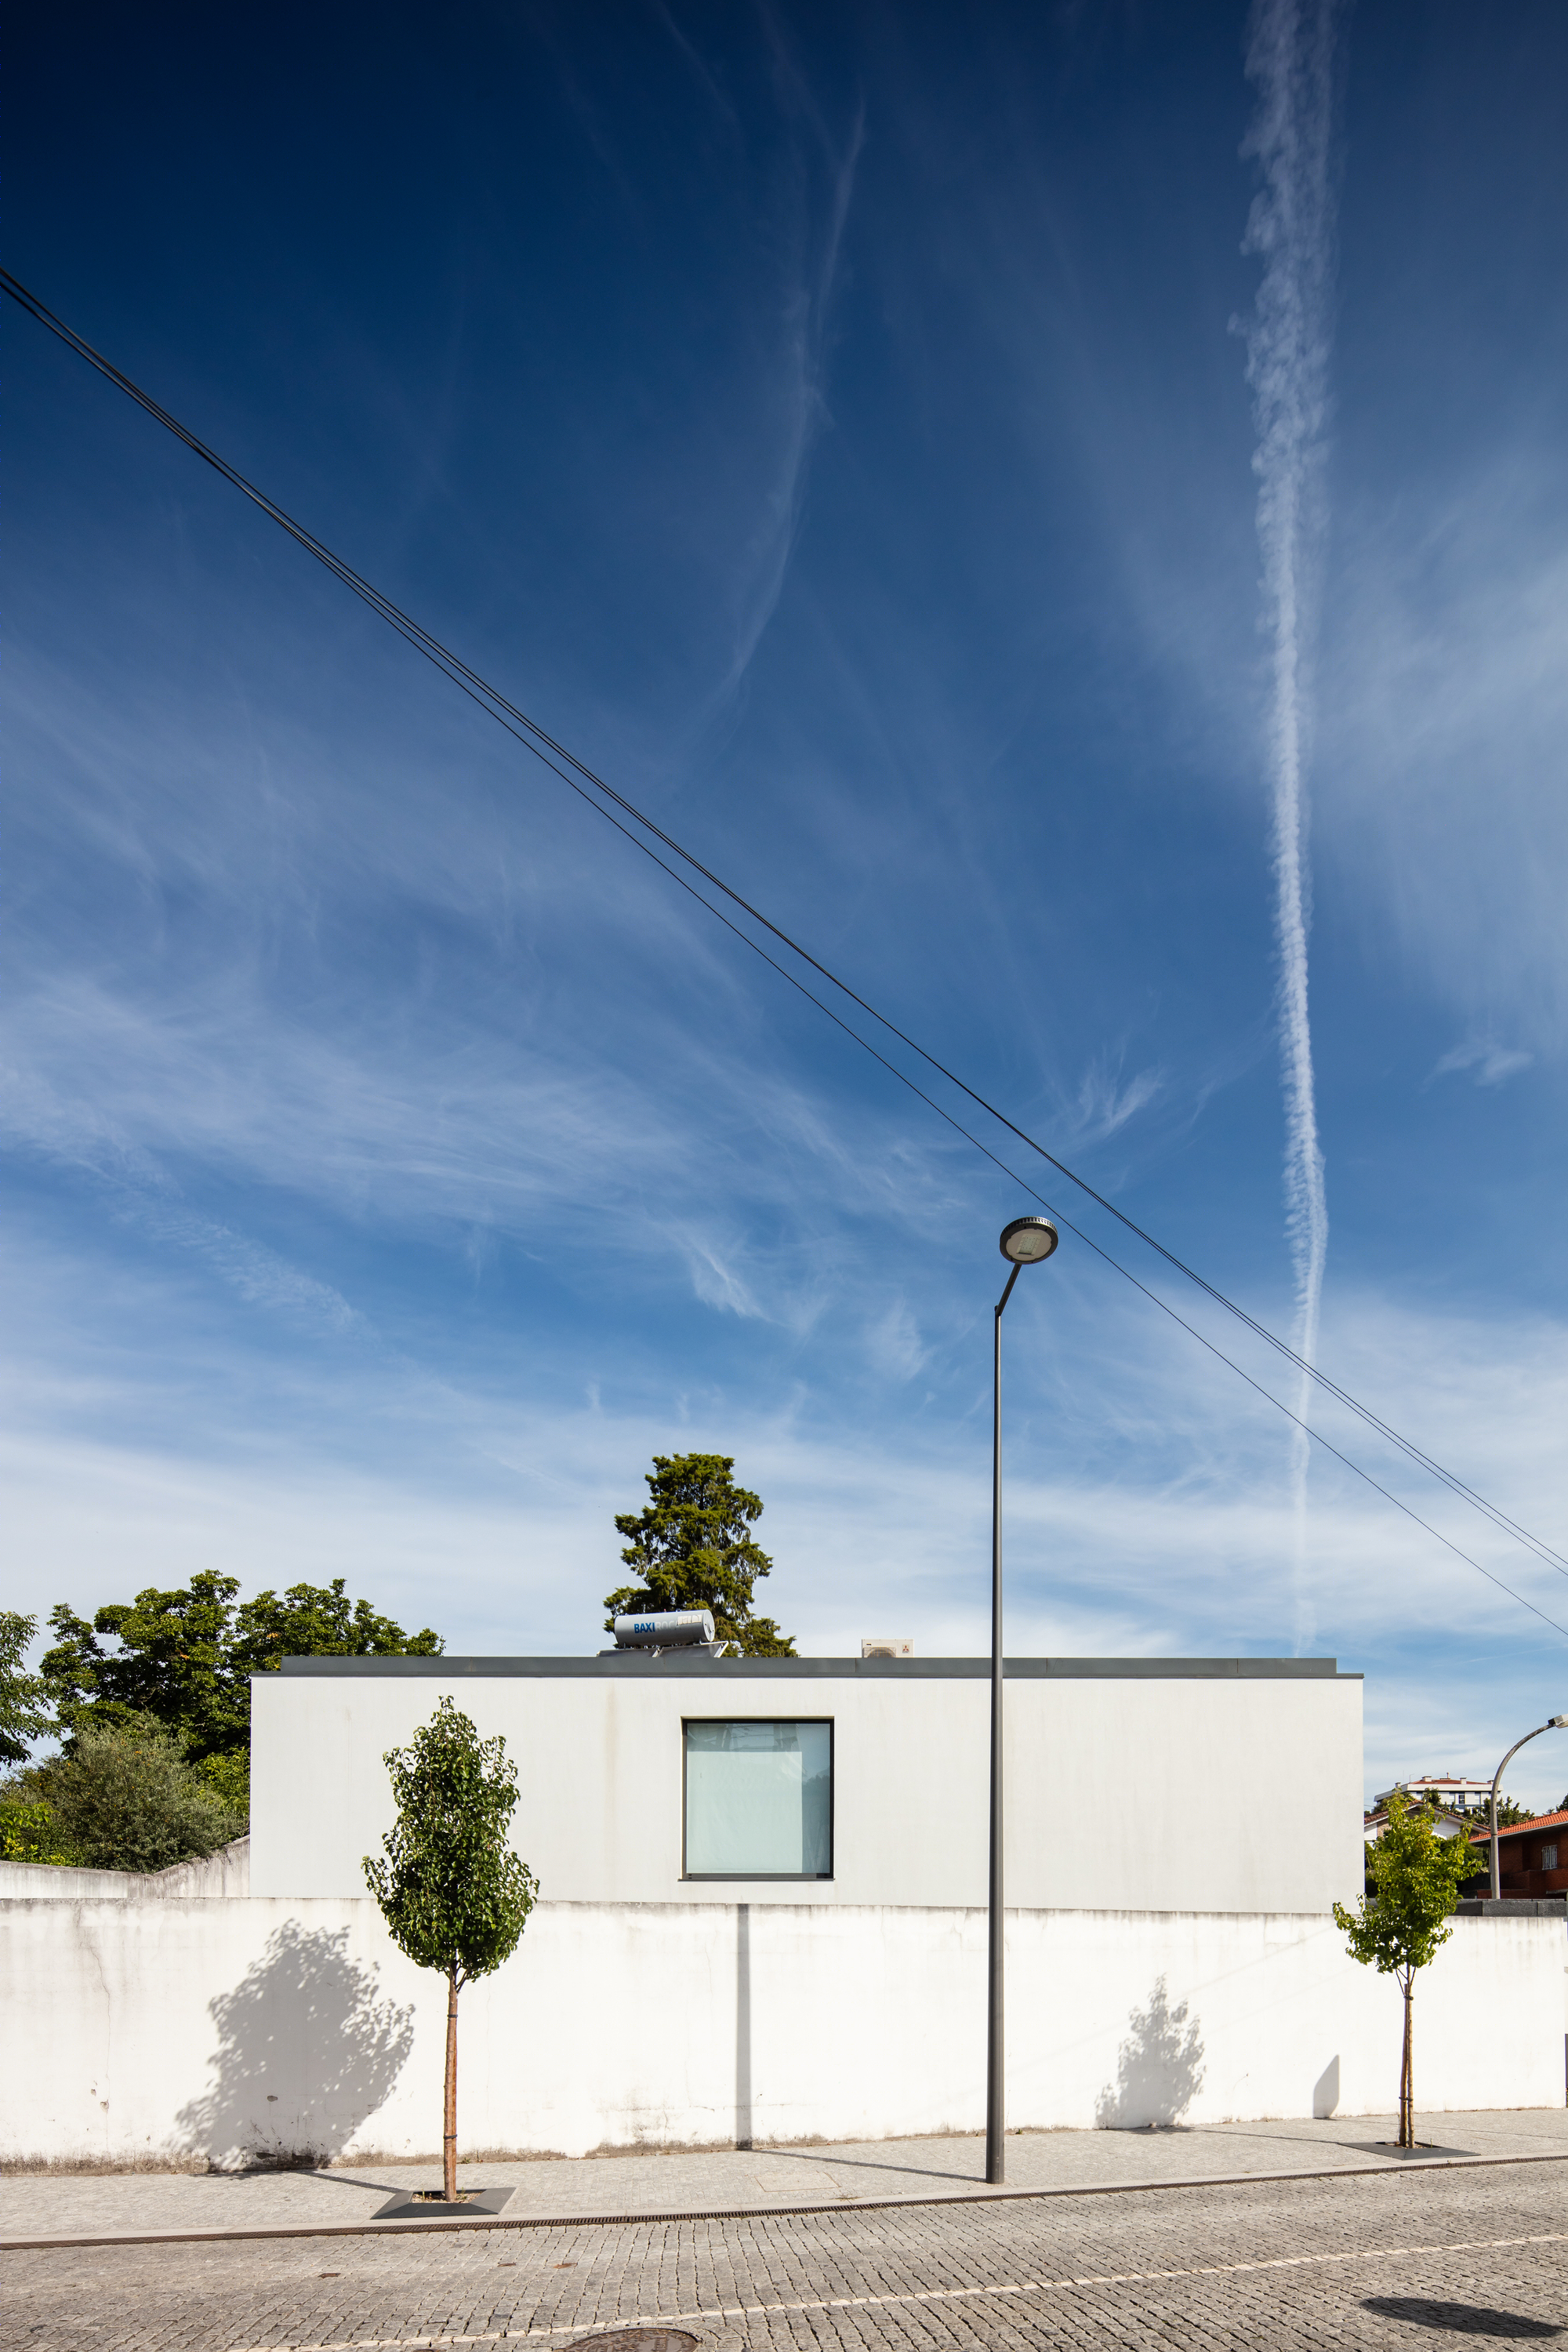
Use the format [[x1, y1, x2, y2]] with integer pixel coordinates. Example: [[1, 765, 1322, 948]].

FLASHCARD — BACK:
[[604, 1454, 794, 1658]]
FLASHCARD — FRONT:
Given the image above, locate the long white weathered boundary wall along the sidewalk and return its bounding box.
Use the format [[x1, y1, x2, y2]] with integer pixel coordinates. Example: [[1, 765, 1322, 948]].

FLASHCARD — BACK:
[[0, 1896, 1568, 2164]]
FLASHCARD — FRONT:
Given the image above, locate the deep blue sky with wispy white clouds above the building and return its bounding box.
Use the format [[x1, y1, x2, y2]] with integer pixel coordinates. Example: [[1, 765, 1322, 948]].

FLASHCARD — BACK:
[[2, 0, 1568, 1802]]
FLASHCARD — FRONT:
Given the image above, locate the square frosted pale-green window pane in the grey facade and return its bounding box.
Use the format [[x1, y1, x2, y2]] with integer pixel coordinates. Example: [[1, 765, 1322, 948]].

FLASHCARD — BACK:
[[687, 1724, 832, 1879]]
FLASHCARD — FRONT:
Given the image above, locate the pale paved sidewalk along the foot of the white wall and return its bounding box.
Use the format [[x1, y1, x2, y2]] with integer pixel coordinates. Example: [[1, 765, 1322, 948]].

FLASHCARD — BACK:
[[0, 2107, 1568, 2246]]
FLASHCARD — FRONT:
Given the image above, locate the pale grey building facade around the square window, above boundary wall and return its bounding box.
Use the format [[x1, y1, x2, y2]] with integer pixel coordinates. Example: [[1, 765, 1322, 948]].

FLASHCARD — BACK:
[[252, 1658, 1363, 1912]]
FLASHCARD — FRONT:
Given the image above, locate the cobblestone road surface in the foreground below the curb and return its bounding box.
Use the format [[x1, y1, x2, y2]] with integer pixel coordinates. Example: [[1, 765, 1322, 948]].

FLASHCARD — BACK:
[[0, 2164, 1568, 2352]]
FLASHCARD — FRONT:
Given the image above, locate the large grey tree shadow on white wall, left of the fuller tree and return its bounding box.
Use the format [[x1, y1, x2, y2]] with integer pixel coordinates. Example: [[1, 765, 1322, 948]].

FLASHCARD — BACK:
[[179, 1919, 414, 2171]]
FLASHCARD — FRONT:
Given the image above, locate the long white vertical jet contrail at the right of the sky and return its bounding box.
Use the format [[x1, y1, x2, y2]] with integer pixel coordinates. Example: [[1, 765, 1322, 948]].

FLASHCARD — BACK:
[[1241, 0, 1338, 1651]]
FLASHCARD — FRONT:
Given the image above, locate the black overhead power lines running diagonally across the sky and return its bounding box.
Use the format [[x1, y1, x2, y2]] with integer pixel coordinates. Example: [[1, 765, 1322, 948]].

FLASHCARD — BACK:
[[0, 266, 1568, 1637]]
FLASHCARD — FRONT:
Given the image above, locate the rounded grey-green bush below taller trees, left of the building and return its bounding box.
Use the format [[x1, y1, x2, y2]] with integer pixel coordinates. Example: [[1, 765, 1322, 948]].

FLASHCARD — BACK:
[[35, 1717, 242, 1870]]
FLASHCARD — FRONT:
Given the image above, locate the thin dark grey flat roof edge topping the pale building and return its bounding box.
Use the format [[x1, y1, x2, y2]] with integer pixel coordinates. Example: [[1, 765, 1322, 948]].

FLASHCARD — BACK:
[[276, 1649, 1361, 1682]]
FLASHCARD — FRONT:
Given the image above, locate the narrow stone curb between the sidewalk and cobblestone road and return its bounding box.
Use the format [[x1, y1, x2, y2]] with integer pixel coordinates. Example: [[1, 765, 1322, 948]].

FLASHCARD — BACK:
[[0, 2147, 1568, 2253]]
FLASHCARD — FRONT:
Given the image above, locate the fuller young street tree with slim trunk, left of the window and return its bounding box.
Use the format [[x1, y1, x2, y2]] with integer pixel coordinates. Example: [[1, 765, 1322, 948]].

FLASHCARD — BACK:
[[365, 1698, 539, 2204]]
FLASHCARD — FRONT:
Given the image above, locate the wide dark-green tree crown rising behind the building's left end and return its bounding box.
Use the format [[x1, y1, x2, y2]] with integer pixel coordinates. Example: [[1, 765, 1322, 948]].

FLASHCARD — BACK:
[[42, 1569, 442, 1811]]
